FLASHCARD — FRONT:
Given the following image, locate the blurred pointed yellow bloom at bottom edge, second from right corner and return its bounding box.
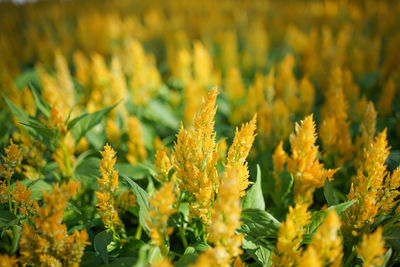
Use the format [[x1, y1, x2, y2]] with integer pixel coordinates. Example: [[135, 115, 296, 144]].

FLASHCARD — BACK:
[[305, 210, 343, 266]]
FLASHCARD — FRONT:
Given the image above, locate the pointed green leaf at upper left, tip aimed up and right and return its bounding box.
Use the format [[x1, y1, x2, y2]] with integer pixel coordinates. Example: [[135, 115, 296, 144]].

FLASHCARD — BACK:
[[67, 103, 118, 143]]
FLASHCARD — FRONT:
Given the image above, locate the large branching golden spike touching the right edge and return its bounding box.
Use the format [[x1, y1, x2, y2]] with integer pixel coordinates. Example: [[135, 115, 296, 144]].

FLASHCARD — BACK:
[[344, 130, 400, 235]]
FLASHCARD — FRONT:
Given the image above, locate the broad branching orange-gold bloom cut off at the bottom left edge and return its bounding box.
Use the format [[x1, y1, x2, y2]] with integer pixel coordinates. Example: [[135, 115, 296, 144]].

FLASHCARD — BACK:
[[20, 181, 90, 266]]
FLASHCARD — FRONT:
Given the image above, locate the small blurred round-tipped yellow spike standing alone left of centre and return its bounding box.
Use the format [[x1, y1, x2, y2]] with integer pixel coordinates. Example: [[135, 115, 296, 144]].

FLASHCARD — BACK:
[[126, 116, 147, 165]]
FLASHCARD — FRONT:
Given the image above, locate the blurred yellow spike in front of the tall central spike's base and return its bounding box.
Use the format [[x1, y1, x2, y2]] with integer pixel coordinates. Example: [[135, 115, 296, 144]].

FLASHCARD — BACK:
[[207, 170, 243, 261]]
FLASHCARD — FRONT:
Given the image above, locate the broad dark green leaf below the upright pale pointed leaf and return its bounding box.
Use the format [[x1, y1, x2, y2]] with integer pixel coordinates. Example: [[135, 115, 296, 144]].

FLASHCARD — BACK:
[[238, 209, 280, 238]]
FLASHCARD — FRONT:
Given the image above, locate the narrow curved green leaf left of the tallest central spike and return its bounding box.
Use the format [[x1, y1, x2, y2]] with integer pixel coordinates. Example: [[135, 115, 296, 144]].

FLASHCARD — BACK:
[[121, 175, 150, 232]]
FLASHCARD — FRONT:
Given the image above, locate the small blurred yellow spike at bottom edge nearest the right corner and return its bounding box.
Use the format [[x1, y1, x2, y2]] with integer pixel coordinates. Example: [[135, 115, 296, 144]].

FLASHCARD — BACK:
[[356, 227, 386, 267]]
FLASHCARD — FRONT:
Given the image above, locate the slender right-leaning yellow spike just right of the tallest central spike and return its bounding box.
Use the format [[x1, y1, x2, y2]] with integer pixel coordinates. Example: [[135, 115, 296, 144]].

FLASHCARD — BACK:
[[226, 114, 257, 197]]
